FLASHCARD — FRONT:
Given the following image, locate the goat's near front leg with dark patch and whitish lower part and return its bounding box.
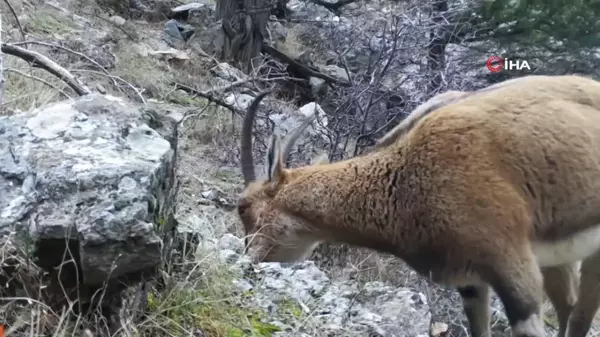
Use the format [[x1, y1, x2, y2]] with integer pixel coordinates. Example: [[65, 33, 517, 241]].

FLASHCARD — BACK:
[[481, 247, 545, 337]]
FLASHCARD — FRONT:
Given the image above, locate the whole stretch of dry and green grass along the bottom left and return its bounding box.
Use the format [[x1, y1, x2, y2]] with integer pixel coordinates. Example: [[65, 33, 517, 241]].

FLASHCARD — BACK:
[[0, 231, 296, 337]]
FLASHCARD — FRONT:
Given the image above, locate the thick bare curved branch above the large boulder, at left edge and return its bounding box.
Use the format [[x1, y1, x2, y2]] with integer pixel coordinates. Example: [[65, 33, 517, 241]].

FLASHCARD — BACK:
[[0, 43, 91, 96]]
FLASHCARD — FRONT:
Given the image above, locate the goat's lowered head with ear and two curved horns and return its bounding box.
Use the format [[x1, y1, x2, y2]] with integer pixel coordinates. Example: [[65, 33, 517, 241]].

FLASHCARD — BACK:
[[237, 92, 327, 262]]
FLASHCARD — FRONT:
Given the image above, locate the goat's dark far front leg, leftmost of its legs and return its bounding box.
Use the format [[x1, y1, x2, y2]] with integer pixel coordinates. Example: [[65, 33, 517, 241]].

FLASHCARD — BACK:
[[458, 284, 491, 337]]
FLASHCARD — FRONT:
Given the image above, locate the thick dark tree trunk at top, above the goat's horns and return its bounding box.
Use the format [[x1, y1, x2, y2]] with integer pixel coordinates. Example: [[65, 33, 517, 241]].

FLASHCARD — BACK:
[[217, 0, 272, 73]]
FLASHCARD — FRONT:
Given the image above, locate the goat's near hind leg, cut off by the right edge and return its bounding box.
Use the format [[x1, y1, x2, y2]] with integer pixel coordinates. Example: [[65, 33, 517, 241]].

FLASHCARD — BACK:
[[566, 251, 600, 337]]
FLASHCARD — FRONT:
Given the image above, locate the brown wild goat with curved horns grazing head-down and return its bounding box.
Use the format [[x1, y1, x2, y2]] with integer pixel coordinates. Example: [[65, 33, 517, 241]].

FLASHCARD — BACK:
[[238, 75, 600, 337]]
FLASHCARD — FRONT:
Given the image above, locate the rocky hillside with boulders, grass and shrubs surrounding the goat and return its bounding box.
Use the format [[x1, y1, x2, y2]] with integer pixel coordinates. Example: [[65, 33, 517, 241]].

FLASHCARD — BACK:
[[0, 0, 600, 337]]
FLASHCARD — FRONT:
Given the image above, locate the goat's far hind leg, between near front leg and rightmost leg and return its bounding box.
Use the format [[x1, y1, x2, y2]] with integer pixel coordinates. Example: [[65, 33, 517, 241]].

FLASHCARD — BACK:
[[542, 263, 579, 337]]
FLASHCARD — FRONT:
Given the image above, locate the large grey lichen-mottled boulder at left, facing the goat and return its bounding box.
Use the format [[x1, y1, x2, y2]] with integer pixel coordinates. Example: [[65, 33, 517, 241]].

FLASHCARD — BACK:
[[0, 94, 177, 287]]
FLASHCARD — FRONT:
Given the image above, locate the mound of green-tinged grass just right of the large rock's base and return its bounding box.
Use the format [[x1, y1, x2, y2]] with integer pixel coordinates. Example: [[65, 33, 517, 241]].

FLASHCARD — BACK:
[[136, 243, 279, 337]]
